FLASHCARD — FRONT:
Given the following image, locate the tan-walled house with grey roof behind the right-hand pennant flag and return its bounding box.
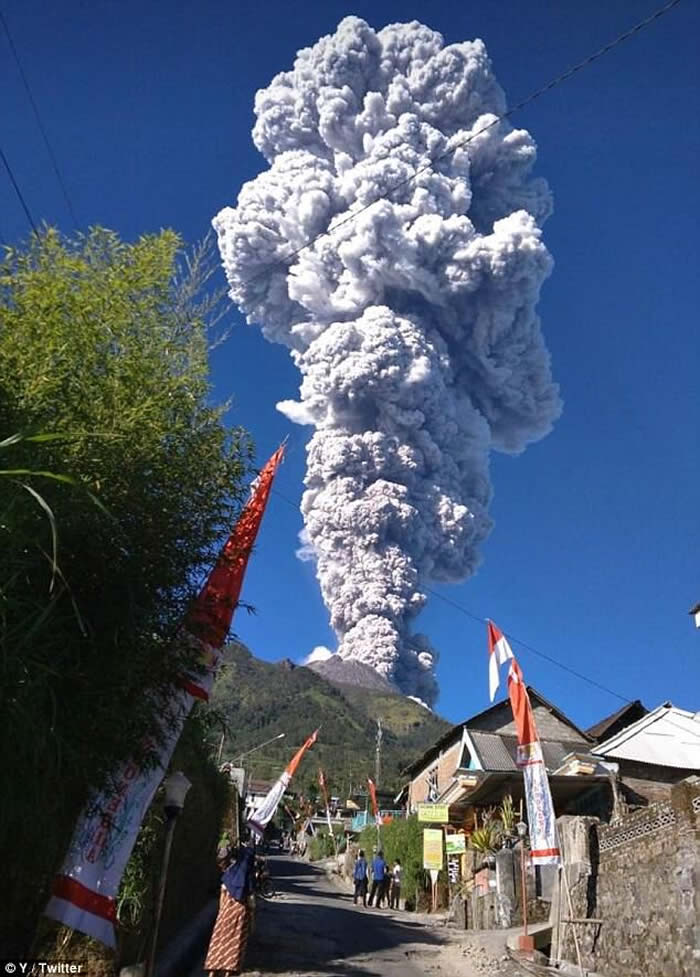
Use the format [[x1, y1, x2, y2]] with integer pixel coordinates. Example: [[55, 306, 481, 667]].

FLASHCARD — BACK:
[[406, 686, 614, 824]]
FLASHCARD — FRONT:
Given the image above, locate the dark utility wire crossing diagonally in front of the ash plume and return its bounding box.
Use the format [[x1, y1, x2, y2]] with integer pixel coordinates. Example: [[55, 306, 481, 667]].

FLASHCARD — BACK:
[[241, 0, 681, 286]]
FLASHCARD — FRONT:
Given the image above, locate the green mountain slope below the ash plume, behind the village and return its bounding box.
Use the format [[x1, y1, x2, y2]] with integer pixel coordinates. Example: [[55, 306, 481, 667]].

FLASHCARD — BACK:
[[211, 644, 450, 799]]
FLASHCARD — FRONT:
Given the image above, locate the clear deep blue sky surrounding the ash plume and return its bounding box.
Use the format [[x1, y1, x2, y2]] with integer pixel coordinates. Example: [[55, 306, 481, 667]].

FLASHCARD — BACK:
[[0, 0, 700, 725]]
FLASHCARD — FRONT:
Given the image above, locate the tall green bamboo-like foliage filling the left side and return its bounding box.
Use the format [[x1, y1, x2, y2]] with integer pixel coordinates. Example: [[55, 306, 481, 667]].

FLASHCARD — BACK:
[[0, 229, 250, 952]]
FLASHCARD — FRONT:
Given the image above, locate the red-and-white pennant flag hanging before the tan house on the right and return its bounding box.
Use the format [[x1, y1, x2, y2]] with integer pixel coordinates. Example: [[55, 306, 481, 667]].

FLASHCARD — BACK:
[[508, 658, 561, 865]]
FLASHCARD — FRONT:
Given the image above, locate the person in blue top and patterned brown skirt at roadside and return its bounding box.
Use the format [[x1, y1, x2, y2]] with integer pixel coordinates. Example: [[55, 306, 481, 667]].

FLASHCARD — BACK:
[[204, 846, 255, 977]]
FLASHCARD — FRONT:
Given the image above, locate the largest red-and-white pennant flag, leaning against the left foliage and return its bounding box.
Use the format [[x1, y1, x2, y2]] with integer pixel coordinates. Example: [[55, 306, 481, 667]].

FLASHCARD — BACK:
[[44, 445, 284, 947]]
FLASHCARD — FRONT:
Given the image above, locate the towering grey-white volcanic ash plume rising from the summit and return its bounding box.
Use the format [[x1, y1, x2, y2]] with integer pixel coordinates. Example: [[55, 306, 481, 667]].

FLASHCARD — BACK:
[[214, 17, 560, 703]]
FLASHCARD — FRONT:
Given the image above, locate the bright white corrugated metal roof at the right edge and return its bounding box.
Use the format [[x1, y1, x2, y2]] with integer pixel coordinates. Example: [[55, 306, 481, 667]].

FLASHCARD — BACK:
[[591, 705, 700, 770]]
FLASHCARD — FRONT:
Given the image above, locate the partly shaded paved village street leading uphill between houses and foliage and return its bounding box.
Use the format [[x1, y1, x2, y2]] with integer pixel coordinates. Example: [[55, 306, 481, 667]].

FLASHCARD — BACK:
[[191, 857, 519, 977]]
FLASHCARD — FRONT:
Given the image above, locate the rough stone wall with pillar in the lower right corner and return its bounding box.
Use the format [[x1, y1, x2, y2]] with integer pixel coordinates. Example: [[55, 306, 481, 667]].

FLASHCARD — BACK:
[[552, 777, 700, 977]]
